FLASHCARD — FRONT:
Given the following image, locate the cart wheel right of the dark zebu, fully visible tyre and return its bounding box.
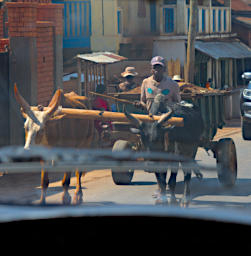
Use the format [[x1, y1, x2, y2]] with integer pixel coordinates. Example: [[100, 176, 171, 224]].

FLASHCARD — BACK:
[[216, 138, 237, 187]]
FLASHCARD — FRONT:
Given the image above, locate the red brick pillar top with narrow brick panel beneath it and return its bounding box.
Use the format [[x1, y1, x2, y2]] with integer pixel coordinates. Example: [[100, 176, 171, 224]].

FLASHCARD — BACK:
[[7, 0, 63, 106]]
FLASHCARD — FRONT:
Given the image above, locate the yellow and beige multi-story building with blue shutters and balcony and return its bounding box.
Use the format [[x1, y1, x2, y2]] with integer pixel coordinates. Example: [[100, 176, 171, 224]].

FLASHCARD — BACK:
[[54, 0, 251, 88]]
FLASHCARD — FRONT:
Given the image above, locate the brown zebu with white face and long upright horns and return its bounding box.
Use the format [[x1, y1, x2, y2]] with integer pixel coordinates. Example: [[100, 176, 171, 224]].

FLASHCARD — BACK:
[[14, 85, 97, 204]]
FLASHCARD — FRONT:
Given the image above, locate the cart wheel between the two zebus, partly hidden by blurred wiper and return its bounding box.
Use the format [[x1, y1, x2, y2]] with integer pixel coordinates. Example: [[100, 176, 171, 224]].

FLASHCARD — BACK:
[[112, 140, 134, 185]]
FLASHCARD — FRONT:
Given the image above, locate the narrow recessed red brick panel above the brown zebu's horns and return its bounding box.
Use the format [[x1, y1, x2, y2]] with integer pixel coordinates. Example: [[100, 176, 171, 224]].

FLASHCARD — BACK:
[[37, 22, 54, 106]]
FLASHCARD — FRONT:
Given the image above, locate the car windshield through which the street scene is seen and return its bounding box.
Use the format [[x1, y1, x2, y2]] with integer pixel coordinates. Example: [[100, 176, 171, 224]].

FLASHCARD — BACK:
[[0, 0, 251, 228]]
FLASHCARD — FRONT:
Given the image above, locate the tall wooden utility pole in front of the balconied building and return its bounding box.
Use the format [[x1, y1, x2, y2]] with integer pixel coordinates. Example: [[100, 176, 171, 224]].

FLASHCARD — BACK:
[[185, 0, 198, 83]]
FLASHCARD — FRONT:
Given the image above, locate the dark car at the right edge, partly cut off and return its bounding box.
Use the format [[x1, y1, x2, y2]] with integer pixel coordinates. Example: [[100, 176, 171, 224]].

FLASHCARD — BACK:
[[240, 72, 251, 140]]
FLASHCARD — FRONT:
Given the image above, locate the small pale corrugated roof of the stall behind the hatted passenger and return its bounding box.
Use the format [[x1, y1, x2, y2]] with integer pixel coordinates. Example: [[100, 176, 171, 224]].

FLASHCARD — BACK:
[[77, 52, 127, 64]]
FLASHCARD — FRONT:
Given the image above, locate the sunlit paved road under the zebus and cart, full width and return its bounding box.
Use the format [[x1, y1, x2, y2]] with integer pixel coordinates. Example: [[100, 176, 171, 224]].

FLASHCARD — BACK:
[[0, 123, 251, 211]]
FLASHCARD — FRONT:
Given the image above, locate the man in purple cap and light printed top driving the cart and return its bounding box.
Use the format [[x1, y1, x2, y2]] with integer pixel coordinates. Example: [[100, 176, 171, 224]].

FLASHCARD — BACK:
[[135, 56, 181, 112]]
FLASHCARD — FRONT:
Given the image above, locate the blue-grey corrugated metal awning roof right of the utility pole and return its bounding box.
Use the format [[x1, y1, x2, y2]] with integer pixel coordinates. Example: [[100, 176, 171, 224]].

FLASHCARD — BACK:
[[195, 41, 251, 59]]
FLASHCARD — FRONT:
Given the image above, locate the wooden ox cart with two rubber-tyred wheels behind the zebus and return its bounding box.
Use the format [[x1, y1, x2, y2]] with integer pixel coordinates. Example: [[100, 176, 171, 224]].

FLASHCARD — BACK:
[[108, 87, 237, 187]]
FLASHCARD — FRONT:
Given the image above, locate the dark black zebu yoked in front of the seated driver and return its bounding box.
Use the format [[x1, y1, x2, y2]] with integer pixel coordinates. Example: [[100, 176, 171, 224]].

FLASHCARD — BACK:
[[125, 95, 203, 206]]
